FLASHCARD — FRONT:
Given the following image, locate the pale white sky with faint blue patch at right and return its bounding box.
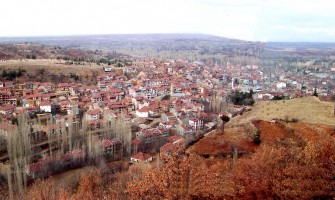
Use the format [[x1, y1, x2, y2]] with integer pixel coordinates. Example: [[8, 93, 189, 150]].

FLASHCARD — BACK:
[[0, 0, 335, 42]]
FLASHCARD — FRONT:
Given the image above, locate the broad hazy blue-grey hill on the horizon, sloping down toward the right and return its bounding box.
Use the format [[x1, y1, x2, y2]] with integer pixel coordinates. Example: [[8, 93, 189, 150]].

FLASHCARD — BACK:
[[0, 34, 263, 64]]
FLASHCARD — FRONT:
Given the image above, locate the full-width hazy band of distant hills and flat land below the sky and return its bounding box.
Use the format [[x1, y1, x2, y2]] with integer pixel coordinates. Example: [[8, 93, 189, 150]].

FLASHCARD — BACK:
[[0, 34, 335, 65]]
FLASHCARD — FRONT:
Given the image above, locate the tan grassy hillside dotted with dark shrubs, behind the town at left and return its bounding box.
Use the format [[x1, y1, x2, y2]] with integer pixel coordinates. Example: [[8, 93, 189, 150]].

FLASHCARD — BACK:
[[0, 42, 131, 84]]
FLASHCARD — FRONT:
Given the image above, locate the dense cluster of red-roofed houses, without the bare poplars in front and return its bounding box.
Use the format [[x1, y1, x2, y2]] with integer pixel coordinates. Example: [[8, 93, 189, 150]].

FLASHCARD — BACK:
[[0, 58, 335, 175]]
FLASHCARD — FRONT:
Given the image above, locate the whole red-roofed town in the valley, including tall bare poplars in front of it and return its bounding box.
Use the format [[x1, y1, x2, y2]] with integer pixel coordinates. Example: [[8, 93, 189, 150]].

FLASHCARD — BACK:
[[0, 55, 335, 181]]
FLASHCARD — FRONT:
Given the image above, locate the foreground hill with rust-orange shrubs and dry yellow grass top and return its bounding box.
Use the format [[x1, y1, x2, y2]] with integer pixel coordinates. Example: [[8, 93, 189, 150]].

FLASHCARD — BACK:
[[2, 97, 335, 199]]
